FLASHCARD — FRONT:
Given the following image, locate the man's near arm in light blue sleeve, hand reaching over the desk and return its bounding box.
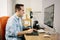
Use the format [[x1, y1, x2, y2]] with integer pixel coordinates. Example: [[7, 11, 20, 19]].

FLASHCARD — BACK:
[[6, 18, 33, 36]]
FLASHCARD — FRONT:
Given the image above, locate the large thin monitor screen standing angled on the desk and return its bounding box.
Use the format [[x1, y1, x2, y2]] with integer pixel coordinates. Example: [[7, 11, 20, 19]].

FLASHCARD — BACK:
[[44, 4, 54, 28]]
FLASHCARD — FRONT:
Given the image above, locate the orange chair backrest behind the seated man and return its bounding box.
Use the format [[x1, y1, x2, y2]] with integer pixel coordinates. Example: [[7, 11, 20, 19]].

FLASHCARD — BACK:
[[0, 16, 9, 40]]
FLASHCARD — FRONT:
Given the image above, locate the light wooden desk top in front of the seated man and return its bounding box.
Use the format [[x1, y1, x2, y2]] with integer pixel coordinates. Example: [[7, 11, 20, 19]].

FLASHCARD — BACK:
[[25, 33, 57, 40]]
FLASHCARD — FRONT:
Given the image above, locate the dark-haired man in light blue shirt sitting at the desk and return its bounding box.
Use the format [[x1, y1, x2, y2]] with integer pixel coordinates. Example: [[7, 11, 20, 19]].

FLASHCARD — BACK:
[[5, 4, 33, 40]]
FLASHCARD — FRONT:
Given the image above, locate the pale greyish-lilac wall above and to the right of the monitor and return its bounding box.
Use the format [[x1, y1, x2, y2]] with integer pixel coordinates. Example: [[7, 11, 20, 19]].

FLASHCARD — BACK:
[[43, 0, 60, 33]]
